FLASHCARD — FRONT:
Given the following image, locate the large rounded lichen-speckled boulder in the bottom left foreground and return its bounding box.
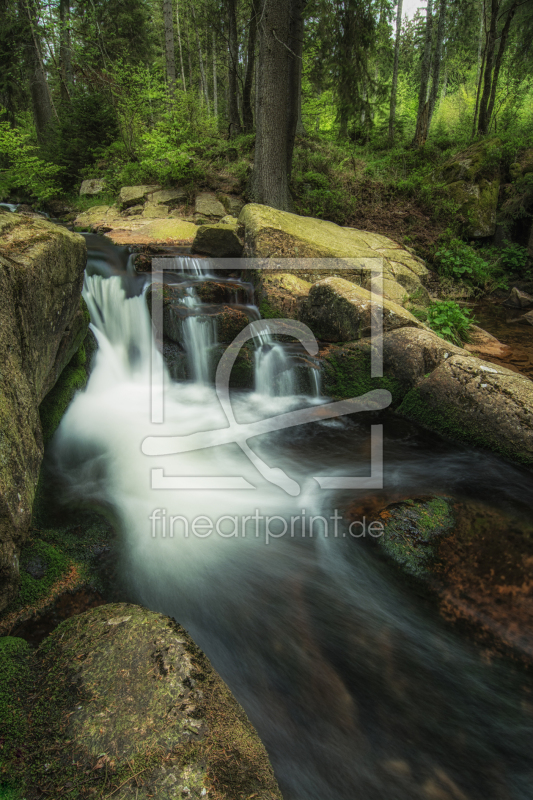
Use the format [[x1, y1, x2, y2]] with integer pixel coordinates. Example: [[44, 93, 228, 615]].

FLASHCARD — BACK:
[[0, 603, 281, 800]]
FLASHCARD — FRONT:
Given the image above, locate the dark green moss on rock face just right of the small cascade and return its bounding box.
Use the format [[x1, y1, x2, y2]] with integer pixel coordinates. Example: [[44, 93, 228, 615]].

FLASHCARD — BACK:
[[323, 347, 404, 405]]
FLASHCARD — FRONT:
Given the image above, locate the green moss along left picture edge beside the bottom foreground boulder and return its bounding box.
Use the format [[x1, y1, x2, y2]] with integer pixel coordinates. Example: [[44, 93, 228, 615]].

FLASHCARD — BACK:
[[0, 636, 31, 772]]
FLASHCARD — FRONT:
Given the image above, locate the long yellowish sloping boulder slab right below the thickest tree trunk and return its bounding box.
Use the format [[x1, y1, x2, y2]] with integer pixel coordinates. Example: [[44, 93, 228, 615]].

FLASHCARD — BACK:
[[239, 204, 428, 303]]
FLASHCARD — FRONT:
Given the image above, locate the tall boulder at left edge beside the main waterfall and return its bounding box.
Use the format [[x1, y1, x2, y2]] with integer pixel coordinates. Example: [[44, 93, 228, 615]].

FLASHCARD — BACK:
[[0, 214, 88, 610]]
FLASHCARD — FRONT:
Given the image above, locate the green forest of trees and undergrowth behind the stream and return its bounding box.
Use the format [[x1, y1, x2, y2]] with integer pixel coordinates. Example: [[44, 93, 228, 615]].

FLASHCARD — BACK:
[[0, 0, 533, 262]]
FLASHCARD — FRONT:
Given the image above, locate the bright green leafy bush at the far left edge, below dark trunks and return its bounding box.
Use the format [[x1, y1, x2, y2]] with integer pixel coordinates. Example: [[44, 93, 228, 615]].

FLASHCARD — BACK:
[[0, 122, 62, 202]]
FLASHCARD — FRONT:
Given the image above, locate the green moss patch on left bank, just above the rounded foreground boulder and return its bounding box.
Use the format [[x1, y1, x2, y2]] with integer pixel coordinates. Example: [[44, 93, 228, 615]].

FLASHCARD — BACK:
[[17, 539, 72, 606]]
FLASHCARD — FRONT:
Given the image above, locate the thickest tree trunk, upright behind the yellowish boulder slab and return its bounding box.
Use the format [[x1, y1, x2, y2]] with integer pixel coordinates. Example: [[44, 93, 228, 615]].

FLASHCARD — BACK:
[[249, 0, 305, 211]]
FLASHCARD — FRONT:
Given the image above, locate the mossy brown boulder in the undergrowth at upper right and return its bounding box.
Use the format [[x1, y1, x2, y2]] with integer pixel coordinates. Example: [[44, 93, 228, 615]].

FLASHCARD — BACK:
[[435, 138, 501, 239]]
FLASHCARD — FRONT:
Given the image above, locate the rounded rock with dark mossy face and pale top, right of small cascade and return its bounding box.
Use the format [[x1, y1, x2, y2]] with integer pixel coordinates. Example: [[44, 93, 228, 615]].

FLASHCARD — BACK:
[[300, 277, 423, 342]]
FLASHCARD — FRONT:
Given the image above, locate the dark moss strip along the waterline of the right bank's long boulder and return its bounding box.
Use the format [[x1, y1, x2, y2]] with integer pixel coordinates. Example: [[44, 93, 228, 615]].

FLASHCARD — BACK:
[[397, 387, 533, 465]]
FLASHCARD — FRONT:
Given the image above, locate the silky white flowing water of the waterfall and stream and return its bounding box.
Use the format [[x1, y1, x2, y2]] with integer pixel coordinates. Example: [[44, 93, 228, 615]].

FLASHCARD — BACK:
[[50, 240, 533, 800]]
